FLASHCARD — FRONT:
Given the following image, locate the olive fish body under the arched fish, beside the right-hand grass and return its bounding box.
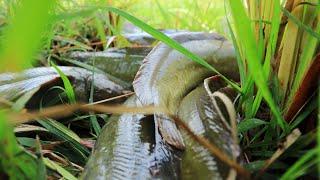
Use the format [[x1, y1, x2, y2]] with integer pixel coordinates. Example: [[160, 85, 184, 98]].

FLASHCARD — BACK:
[[178, 78, 239, 179]]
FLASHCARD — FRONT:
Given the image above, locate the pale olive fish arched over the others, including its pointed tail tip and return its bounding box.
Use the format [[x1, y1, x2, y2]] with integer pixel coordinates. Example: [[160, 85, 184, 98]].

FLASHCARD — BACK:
[[133, 32, 238, 149]]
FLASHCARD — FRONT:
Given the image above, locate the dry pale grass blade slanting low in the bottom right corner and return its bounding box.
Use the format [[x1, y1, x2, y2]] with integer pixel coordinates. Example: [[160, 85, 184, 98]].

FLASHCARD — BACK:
[[258, 129, 301, 177]]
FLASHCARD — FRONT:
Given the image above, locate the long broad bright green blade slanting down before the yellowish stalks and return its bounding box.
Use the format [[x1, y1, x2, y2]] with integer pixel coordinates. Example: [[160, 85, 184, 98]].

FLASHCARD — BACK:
[[229, 0, 288, 131]]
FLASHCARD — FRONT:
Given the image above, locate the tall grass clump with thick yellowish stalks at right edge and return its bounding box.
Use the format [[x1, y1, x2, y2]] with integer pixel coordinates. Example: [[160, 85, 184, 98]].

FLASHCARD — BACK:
[[229, 0, 320, 179]]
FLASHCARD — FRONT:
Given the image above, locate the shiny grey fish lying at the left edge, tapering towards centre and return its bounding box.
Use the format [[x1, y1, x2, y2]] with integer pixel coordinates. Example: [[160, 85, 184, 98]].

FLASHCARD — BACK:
[[0, 66, 125, 105]]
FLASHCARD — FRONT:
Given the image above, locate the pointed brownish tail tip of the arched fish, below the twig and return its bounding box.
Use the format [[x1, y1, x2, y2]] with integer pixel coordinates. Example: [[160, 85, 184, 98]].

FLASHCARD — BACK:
[[154, 114, 185, 150]]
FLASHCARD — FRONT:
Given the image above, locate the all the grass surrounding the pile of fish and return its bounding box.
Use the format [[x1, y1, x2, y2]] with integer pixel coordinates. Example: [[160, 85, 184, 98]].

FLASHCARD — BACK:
[[0, 0, 320, 179]]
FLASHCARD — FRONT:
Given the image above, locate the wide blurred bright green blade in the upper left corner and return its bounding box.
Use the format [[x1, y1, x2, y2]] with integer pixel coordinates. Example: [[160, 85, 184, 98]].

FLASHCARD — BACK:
[[0, 0, 57, 70]]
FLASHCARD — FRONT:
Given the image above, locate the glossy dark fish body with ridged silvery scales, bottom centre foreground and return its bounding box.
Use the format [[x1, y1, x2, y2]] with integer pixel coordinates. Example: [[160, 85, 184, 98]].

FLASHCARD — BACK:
[[82, 96, 180, 180]]
